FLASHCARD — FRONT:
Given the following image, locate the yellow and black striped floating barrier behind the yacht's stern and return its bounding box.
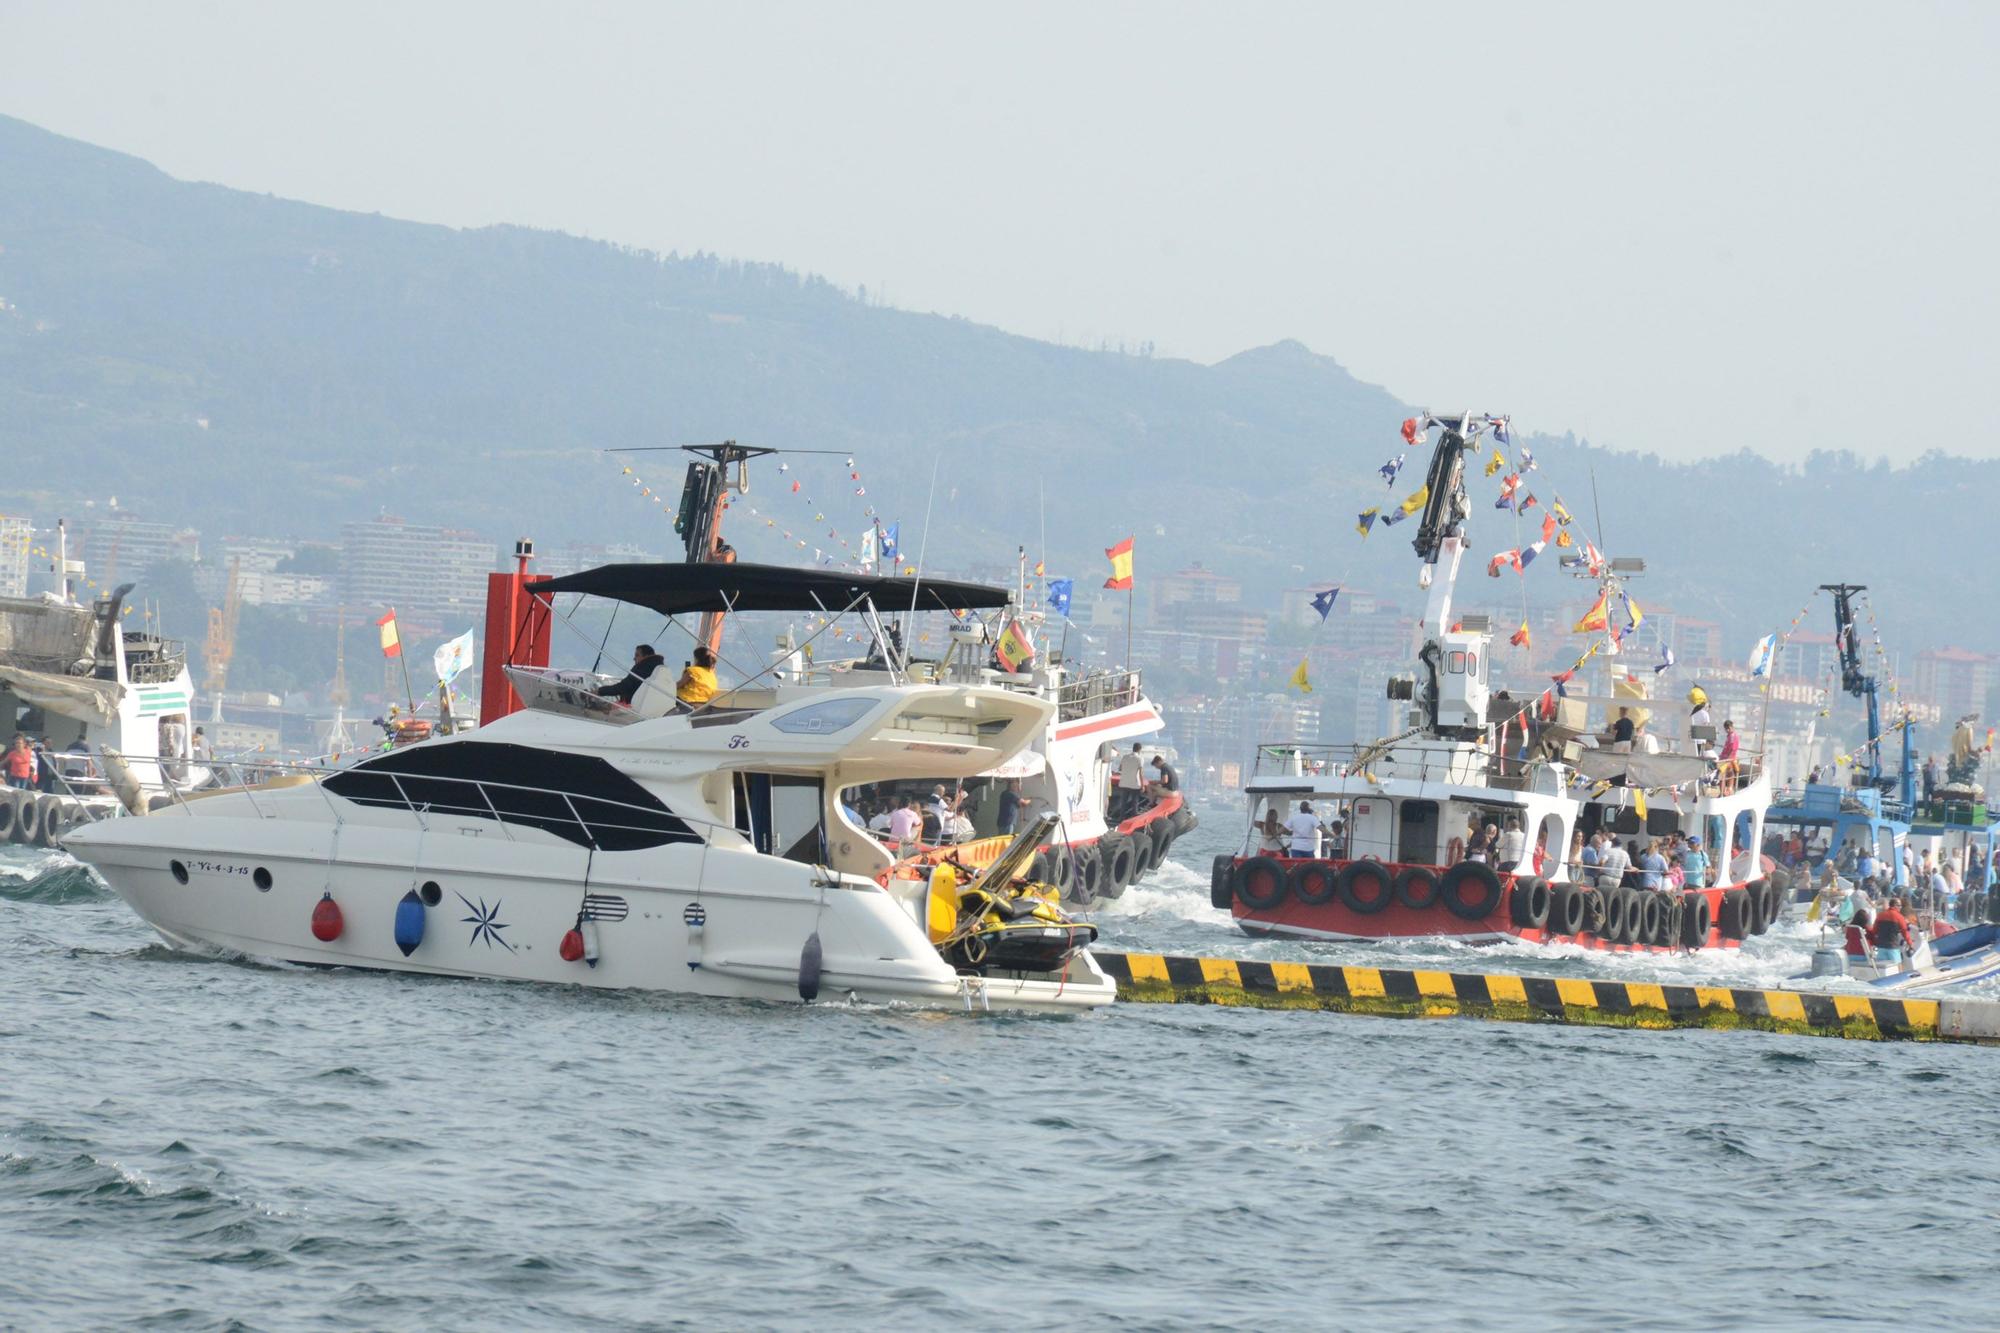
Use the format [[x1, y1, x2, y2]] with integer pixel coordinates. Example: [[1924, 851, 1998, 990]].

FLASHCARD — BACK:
[[1092, 949, 2000, 1043]]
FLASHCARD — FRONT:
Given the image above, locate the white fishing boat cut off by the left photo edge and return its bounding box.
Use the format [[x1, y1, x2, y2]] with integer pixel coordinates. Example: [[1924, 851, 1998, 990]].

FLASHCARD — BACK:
[[0, 524, 208, 847]]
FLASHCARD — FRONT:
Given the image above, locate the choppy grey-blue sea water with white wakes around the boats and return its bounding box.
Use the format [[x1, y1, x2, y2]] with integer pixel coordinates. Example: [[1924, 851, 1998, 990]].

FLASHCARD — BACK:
[[0, 831, 2000, 1329]]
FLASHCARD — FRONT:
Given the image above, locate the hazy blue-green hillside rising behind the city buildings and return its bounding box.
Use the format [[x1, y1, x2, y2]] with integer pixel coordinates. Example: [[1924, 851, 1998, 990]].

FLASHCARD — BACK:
[[0, 109, 2000, 668]]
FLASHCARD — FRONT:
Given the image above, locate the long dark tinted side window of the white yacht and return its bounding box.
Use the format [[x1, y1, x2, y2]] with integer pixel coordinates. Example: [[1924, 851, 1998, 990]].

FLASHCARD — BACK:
[[326, 741, 700, 851]]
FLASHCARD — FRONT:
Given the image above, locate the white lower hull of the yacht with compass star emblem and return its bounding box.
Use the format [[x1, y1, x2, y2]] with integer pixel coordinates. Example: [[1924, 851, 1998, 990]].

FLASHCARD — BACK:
[[68, 815, 1116, 1011]]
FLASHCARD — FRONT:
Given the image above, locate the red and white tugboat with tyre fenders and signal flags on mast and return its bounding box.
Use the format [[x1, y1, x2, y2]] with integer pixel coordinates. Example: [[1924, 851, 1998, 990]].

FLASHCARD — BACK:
[[1210, 414, 1780, 951]]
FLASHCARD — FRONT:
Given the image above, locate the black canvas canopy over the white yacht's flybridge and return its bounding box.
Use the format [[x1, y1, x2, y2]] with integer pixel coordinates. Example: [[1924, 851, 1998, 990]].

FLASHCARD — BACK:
[[526, 564, 1008, 616]]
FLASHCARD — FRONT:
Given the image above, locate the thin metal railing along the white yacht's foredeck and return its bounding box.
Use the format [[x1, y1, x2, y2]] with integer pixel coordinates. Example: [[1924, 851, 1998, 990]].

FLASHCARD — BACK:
[[152, 759, 740, 847]]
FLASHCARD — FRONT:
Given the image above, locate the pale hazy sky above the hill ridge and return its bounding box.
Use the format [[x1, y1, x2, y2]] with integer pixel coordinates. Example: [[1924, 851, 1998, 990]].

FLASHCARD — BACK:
[[0, 0, 2000, 458]]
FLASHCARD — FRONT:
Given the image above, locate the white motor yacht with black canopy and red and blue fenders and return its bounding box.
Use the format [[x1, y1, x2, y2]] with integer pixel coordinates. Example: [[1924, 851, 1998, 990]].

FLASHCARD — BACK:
[[66, 560, 1114, 1011]]
